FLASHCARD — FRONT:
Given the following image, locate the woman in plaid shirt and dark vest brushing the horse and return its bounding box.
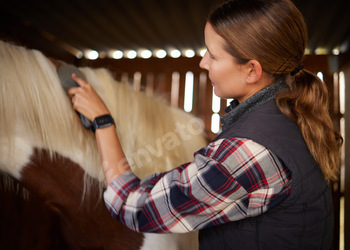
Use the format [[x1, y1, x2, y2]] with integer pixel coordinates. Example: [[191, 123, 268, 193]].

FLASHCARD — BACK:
[[69, 0, 341, 249]]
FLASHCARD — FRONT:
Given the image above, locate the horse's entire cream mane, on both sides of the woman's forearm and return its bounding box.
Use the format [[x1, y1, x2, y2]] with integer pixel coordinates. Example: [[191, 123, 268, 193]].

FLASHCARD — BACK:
[[0, 41, 206, 190]]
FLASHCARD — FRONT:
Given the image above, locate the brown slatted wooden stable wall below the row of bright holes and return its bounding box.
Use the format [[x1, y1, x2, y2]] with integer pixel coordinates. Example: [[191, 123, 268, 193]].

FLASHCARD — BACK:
[[78, 55, 344, 249]]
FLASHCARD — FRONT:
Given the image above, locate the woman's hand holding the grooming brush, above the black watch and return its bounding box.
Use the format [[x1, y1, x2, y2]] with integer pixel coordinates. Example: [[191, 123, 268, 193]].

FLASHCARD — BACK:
[[68, 74, 110, 121]]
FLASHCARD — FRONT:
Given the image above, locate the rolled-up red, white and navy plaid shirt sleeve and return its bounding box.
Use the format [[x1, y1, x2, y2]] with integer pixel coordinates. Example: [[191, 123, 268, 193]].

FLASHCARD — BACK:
[[104, 138, 291, 233]]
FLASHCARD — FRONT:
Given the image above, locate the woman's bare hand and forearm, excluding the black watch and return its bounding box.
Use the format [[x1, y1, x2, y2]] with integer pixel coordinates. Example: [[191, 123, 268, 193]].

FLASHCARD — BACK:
[[68, 74, 131, 185]]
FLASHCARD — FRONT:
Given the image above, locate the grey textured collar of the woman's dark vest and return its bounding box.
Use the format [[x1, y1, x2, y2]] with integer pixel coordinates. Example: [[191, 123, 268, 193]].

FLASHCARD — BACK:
[[220, 81, 287, 130]]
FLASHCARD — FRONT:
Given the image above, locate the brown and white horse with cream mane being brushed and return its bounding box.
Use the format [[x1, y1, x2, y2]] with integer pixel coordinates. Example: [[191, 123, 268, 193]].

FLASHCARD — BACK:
[[0, 41, 207, 250]]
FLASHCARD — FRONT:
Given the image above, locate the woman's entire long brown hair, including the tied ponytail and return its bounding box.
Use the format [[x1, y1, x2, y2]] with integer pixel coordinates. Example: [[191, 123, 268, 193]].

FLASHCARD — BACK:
[[208, 0, 342, 180]]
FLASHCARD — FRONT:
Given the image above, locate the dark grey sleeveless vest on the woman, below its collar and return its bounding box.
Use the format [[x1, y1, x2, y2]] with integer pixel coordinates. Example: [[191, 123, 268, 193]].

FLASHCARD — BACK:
[[199, 99, 333, 250]]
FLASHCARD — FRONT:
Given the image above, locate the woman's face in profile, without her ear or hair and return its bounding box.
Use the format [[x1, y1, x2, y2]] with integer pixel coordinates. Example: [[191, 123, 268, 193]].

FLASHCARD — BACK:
[[199, 23, 252, 102]]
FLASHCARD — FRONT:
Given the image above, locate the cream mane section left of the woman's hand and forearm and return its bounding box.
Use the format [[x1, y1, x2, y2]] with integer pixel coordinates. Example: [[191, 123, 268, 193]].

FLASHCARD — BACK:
[[0, 41, 102, 182]]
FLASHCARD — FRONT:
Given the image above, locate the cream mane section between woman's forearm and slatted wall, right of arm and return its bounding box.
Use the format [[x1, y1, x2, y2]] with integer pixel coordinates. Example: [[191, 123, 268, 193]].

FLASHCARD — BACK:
[[80, 67, 206, 178]]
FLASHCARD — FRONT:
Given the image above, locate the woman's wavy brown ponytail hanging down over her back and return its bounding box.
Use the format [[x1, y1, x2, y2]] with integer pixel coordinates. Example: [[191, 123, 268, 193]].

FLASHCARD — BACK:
[[276, 70, 342, 181]]
